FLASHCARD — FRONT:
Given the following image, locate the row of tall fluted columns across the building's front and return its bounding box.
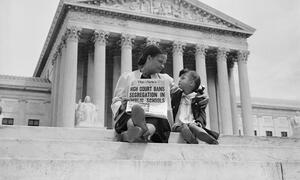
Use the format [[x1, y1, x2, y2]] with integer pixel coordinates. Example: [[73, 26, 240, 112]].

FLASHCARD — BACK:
[[52, 27, 253, 135]]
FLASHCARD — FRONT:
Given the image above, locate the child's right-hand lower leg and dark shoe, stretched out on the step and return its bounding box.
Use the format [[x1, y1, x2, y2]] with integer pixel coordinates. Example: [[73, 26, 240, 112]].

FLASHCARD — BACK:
[[189, 123, 218, 144]]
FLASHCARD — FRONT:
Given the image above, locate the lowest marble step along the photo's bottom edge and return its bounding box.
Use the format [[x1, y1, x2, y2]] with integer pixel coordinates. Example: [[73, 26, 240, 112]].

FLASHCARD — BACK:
[[0, 159, 290, 180]]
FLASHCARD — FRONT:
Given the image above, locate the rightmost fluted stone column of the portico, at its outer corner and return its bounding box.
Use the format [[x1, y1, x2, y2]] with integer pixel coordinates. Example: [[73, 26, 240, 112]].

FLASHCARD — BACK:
[[238, 51, 254, 136]]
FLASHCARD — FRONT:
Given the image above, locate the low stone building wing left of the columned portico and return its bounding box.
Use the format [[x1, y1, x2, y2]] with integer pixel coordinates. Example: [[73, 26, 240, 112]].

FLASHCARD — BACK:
[[0, 75, 52, 126]]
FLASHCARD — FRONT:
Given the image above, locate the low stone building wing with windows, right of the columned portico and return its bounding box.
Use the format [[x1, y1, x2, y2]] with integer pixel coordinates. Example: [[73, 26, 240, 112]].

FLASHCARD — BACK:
[[237, 98, 300, 137]]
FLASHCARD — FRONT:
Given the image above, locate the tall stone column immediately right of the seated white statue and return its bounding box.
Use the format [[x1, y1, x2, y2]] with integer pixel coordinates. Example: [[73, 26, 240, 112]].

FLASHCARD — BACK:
[[93, 31, 108, 127]]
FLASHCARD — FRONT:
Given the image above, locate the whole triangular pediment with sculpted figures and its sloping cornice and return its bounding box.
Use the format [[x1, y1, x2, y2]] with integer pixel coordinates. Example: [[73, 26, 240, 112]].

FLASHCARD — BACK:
[[78, 0, 254, 34]]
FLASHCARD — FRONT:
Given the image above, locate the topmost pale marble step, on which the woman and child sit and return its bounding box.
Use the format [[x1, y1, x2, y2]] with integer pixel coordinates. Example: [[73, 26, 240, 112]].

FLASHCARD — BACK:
[[0, 125, 300, 147]]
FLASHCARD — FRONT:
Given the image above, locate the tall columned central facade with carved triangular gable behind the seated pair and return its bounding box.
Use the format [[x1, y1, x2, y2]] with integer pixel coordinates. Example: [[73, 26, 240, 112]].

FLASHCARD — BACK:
[[34, 0, 255, 135]]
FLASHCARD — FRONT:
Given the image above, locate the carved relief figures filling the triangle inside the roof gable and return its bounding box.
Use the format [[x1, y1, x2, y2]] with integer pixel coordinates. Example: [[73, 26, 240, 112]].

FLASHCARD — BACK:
[[80, 0, 240, 29]]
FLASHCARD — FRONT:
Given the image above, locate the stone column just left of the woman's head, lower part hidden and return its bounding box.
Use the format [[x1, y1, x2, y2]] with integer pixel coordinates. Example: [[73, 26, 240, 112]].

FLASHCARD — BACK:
[[121, 34, 134, 74]]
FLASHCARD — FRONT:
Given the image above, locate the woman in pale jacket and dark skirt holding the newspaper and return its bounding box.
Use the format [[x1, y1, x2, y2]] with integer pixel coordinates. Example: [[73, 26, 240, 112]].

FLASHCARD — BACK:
[[111, 45, 174, 143]]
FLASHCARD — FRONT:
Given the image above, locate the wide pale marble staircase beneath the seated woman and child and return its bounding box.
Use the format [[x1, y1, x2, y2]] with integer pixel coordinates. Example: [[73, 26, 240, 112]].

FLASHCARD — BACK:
[[0, 126, 300, 180]]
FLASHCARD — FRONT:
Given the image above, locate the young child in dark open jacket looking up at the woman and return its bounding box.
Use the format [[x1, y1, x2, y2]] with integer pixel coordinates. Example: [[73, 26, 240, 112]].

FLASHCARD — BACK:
[[171, 69, 219, 144]]
